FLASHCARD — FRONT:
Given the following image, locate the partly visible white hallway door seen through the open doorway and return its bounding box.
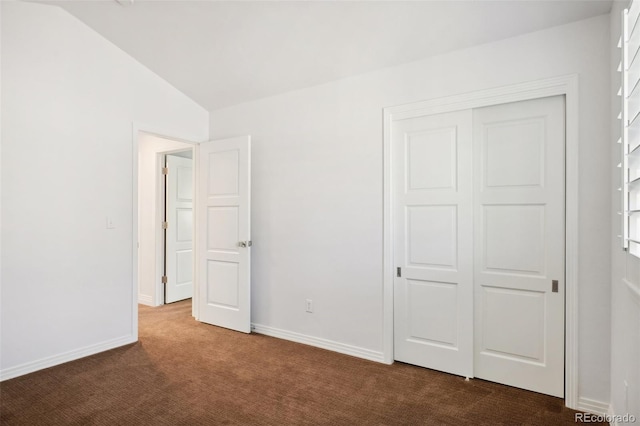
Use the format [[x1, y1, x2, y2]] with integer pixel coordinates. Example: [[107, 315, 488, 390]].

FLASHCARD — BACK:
[[165, 155, 193, 303]]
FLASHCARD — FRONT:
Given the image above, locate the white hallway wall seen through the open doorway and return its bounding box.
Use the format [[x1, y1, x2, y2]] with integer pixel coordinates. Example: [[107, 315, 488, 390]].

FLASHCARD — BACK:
[[138, 132, 195, 306]]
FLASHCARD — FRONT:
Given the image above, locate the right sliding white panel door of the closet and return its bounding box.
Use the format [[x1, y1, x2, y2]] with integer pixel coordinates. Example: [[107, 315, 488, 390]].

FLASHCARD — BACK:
[[474, 96, 565, 397]]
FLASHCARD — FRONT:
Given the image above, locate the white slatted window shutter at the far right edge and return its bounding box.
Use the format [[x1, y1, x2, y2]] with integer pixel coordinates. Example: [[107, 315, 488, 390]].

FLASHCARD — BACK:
[[618, 0, 640, 257]]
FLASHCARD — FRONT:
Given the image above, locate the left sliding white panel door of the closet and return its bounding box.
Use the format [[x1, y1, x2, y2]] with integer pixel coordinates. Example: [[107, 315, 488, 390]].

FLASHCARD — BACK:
[[392, 110, 473, 377]]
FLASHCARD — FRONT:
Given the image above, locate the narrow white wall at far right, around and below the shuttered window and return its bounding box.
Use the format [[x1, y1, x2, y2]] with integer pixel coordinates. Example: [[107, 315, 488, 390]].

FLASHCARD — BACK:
[[609, 2, 640, 422]]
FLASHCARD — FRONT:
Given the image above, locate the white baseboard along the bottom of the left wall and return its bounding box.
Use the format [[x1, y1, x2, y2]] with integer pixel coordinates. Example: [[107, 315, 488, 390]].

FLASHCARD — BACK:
[[0, 335, 137, 382]]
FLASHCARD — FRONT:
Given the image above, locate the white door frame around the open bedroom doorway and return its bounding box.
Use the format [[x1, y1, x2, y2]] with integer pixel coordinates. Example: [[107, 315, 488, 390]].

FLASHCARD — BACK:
[[131, 122, 199, 341]]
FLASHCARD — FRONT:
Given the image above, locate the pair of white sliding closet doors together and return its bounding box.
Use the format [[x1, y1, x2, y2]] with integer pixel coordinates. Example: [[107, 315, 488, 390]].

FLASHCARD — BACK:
[[385, 77, 575, 406]]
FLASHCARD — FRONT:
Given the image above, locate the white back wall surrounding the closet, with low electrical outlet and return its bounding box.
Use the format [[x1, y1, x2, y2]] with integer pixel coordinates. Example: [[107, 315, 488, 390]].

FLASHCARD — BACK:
[[211, 16, 611, 406]]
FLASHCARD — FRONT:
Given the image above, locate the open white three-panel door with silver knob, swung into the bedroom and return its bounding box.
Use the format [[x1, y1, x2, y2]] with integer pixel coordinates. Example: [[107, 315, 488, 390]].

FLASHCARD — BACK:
[[196, 136, 251, 333]]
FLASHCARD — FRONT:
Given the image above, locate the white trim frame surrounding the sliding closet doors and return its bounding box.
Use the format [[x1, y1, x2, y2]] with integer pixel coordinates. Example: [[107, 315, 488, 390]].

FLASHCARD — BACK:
[[383, 74, 579, 409]]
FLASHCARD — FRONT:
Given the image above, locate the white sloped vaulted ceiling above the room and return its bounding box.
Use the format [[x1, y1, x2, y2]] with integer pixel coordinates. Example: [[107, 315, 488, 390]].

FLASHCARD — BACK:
[[44, 0, 611, 110]]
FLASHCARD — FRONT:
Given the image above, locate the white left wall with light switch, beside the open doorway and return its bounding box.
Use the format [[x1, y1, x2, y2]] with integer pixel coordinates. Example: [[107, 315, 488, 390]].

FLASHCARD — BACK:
[[0, 1, 208, 378]]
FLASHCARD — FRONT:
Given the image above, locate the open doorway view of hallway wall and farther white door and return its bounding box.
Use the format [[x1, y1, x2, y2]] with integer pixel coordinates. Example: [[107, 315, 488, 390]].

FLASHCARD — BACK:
[[137, 131, 196, 316]]
